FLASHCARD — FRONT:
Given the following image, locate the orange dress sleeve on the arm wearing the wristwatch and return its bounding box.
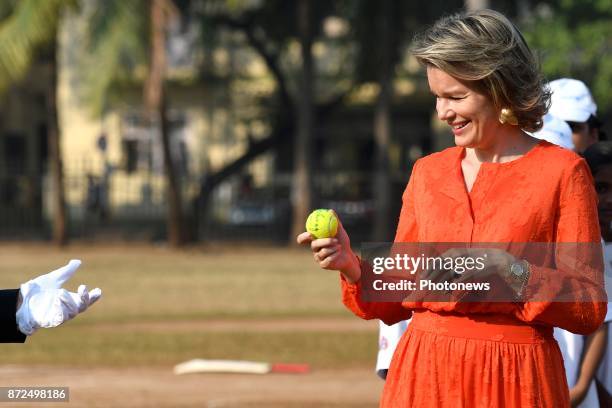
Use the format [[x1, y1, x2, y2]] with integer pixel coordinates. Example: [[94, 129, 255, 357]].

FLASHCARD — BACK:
[[515, 159, 607, 334]]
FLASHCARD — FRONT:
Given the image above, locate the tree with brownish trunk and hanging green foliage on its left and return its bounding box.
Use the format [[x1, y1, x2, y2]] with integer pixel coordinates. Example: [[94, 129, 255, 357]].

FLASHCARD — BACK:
[[83, 0, 187, 247]]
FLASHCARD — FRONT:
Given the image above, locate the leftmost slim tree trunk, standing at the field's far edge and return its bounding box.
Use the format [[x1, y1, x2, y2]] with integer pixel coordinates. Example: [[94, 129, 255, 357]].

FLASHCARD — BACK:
[[46, 31, 68, 246]]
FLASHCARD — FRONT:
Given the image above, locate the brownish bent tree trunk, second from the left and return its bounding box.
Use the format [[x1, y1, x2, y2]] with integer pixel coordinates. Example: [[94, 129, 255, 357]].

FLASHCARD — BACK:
[[144, 0, 186, 247]]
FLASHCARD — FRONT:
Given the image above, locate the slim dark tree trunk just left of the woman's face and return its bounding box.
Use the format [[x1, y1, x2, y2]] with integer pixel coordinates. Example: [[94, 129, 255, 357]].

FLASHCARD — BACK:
[[372, 0, 393, 242]]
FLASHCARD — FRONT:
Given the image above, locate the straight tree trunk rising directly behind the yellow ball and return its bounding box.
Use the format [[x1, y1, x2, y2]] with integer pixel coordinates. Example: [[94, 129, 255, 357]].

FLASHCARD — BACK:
[[290, 0, 314, 242]]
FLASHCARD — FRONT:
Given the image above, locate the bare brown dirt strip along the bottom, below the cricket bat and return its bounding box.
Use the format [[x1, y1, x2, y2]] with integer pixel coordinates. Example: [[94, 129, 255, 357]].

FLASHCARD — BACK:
[[0, 366, 383, 408]]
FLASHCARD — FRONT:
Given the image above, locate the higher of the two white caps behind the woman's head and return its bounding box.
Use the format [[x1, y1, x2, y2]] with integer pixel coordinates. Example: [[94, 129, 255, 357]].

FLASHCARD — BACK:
[[548, 78, 597, 122]]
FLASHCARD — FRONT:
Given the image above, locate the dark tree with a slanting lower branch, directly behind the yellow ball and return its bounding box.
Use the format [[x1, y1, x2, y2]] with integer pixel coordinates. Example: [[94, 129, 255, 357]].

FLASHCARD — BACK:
[[200, 0, 345, 241]]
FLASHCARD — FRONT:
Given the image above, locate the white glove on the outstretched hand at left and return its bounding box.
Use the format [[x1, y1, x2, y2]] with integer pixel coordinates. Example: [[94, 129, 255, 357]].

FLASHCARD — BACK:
[[17, 259, 102, 336]]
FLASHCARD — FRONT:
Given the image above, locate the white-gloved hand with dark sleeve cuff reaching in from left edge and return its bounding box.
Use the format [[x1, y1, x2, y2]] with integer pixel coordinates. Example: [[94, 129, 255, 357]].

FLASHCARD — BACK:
[[0, 259, 102, 343]]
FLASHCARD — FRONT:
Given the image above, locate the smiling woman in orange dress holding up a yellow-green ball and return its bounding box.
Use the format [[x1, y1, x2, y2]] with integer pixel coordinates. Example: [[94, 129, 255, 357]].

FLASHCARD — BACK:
[[297, 10, 606, 408]]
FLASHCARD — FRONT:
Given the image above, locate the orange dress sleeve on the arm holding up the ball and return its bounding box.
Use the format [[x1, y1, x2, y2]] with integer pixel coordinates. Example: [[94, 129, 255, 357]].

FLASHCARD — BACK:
[[340, 161, 418, 325]]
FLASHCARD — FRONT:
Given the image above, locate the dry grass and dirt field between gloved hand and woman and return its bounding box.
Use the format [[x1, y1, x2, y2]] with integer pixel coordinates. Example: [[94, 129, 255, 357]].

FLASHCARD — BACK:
[[0, 244, 383, 408]]
